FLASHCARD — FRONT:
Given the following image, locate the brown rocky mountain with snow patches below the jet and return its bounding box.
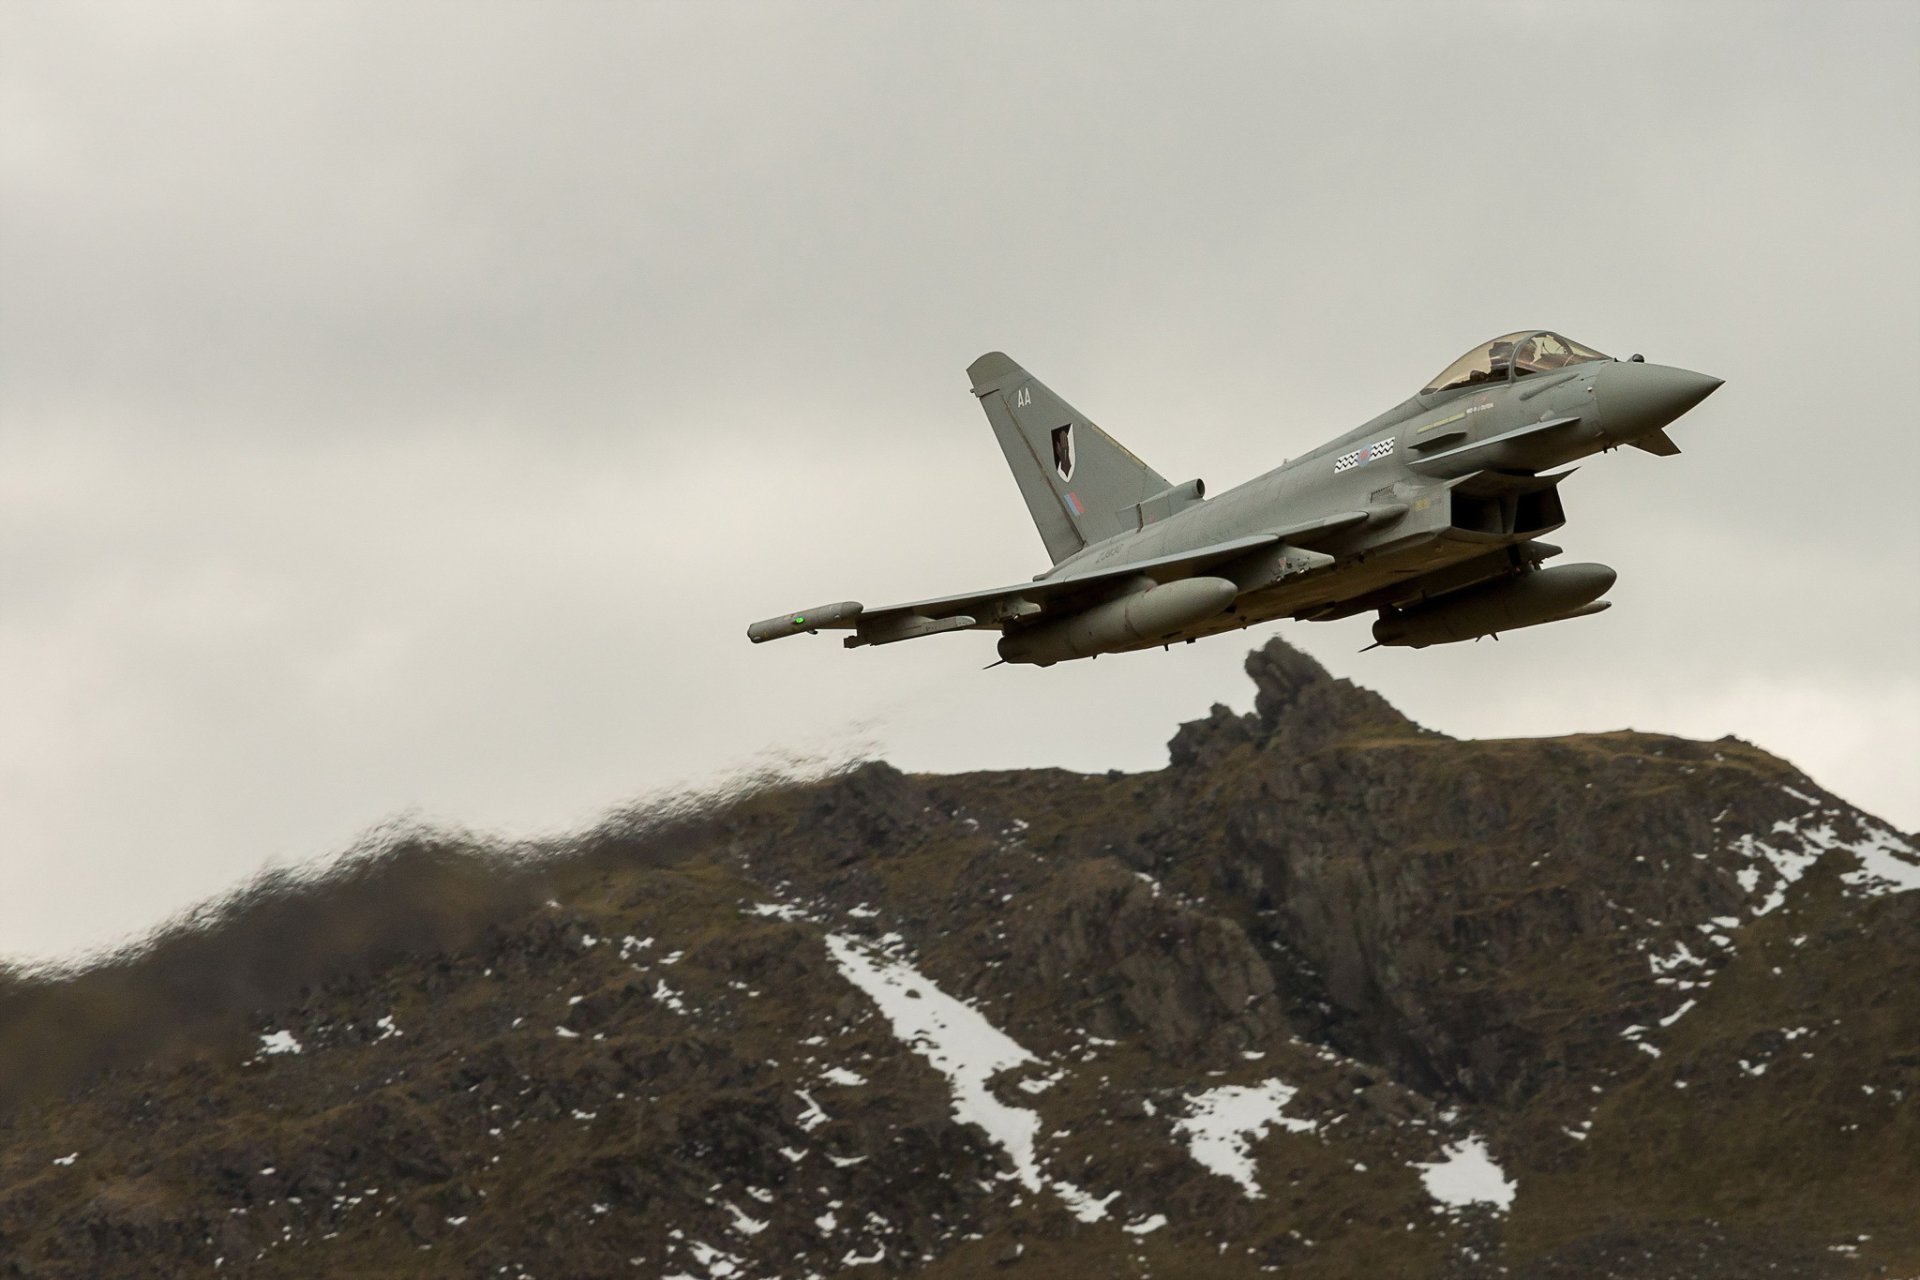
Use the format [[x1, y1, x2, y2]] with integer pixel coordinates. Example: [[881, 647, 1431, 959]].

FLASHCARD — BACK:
[[0, 641, 1920, 1280]]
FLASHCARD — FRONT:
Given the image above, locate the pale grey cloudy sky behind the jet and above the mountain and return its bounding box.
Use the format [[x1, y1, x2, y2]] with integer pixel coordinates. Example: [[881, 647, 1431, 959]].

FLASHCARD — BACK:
[[0, 0, 1920, 958]]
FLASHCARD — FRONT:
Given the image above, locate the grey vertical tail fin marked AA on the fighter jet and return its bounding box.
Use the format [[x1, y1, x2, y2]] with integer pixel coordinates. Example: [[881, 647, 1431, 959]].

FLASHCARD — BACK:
[[966, 351, 1169, 564]]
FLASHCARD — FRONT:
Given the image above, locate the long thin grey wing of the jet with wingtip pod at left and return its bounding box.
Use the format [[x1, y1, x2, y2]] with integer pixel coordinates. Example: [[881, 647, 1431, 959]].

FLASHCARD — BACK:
[[747, 533, 1283, 649]]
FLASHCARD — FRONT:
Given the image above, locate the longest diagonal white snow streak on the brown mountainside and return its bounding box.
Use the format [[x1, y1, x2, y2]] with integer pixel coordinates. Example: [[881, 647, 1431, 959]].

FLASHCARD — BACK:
[[828, 933, 1117, 1222]]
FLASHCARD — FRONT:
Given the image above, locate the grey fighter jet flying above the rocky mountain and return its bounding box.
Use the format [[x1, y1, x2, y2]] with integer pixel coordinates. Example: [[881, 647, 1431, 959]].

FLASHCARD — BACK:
[[747, 330, 1720, 666]]
